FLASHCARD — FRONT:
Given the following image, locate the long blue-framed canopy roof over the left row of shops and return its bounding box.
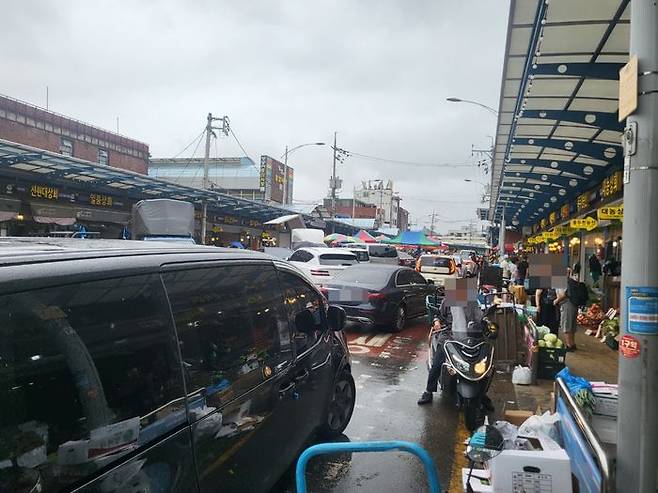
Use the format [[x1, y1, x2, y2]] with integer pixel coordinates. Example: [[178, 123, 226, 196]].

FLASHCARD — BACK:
[[0, 139, 359, 232]]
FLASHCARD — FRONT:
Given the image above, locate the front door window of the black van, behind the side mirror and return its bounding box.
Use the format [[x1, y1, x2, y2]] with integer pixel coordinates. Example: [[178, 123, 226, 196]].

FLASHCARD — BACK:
[[279, 271, 326, 354]]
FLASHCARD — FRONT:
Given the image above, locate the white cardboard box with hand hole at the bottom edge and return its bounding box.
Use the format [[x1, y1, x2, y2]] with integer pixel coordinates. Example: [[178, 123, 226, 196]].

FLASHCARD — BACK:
[[489, 450, 572, 493]]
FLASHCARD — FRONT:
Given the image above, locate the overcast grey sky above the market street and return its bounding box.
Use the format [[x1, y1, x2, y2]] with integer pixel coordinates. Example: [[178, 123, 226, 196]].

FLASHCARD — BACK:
[[0, 0, 509, 231]]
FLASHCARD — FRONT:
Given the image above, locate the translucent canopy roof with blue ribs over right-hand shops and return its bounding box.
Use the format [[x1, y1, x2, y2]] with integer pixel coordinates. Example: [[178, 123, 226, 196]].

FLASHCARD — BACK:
[[488, 0, 630, 226]]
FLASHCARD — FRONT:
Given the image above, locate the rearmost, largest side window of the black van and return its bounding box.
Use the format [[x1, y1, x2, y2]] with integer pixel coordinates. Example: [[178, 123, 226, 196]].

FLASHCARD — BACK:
[[0, 276, 185, 493]]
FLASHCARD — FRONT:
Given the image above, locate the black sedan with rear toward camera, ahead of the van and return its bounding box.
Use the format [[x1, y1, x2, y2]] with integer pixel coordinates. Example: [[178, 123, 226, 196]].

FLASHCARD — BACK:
[[323, 264, 436, 332]]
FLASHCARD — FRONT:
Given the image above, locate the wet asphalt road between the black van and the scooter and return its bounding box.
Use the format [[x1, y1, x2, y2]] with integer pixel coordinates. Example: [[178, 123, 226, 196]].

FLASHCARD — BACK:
[[276, 318, 514, 493]]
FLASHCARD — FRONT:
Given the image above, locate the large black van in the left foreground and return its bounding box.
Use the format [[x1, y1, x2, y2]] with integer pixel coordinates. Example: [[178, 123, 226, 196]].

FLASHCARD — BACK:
[[0, 238, 355, 493]]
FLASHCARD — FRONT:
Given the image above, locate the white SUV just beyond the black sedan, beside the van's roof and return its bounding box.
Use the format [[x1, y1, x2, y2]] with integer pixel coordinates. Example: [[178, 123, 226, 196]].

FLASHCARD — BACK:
[[288, 247, 359, 284]]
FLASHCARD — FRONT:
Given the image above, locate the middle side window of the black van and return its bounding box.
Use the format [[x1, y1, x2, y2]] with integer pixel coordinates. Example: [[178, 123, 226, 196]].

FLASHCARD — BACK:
[[164, 265, 292, 407]]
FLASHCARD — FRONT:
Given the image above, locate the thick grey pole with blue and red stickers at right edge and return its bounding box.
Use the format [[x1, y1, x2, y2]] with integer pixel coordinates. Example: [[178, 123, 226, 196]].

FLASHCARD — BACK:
[[616, 0, 658, 492]]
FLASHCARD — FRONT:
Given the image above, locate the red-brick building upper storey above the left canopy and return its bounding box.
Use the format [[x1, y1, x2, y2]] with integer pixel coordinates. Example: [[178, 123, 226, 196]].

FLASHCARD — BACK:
[[0, 96, 149, 174]]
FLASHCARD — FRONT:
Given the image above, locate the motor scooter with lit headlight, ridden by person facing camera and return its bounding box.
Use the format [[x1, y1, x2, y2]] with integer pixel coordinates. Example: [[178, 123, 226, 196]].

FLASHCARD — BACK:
[[428, 300, 498, 431]]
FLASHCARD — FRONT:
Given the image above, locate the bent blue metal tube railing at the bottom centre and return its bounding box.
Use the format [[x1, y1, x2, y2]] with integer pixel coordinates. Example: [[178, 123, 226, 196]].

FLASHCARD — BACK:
[[295, 440, 441, 493]]
